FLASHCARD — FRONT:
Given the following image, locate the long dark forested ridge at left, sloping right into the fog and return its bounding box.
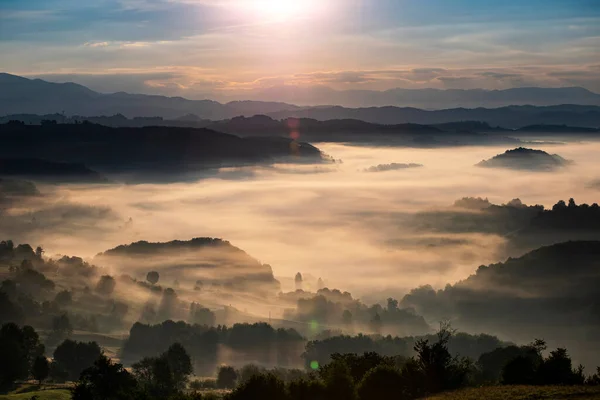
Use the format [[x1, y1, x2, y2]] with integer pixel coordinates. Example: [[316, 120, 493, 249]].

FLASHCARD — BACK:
[[0, 123, 324, 180]]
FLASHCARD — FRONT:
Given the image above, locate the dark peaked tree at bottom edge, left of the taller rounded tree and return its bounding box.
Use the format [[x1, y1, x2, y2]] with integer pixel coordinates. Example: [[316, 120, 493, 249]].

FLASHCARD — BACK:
[[72, 354, 137, 400]]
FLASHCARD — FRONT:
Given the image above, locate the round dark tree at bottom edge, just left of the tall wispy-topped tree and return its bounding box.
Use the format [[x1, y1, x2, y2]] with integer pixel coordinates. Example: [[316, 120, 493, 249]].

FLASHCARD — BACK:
[[358, 365, 404, 400]]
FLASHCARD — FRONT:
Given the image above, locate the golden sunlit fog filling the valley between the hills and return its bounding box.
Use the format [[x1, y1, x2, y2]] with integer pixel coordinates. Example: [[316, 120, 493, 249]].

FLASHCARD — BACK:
[[0, 143, 600, 300]]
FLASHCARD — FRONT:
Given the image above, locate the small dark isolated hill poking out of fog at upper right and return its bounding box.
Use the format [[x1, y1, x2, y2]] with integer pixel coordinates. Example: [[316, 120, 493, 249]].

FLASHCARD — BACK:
[[477, 147, 571, 171]]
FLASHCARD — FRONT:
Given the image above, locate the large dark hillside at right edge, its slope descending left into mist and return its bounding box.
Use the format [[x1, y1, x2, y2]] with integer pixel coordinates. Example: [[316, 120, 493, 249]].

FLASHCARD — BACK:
[[401, 241, 600, 365]]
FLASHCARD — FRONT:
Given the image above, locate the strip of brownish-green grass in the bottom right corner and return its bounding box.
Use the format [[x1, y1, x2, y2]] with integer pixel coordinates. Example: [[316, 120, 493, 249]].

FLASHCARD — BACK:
[[427, 386, 600, 400]]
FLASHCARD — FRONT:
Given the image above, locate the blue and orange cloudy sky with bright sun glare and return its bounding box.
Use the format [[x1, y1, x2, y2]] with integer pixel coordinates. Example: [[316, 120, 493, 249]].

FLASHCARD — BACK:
[[0, 0, 600, 100]]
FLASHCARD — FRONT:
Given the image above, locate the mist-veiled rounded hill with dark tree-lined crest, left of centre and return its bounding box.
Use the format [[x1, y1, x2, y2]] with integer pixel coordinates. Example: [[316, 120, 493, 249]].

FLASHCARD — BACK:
[[94, 238, 279, 293]]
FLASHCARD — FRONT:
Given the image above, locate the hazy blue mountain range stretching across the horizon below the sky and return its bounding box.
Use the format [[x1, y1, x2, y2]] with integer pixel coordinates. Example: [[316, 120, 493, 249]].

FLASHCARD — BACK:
[[0, 74, 600, 128]]
